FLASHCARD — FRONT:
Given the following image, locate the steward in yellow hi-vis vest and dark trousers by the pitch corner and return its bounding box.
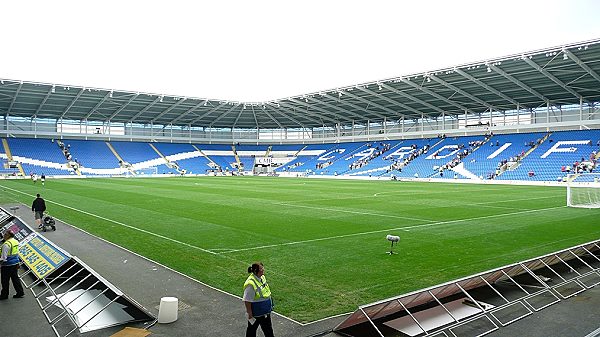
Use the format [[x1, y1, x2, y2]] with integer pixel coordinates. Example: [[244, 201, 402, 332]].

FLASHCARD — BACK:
[[242, 262, 273, 337]]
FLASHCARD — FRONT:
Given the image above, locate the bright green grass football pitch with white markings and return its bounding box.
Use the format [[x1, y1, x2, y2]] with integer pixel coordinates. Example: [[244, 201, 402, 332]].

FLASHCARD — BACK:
[[0, 177, 600, 322]]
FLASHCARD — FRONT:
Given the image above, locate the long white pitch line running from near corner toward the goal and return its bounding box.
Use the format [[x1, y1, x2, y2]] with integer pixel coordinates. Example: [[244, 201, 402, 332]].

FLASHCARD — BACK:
[[220, 206, 567, 254]]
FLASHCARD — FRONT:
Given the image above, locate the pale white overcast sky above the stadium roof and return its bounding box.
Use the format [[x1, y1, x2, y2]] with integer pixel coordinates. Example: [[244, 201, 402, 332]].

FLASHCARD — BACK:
[[0, 0, 600, 102]]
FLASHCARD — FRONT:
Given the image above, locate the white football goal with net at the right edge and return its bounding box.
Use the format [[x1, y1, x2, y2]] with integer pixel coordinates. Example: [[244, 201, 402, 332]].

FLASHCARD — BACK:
[[567, 173, 600, 208]]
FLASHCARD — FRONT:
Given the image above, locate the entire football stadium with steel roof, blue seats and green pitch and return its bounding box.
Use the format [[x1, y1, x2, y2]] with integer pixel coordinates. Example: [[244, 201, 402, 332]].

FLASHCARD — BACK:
[[0, 5, 600, 337]]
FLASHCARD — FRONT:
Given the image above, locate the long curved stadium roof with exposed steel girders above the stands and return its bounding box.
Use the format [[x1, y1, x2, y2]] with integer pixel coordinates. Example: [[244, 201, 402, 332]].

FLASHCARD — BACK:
[[0, 40, 600, 129]]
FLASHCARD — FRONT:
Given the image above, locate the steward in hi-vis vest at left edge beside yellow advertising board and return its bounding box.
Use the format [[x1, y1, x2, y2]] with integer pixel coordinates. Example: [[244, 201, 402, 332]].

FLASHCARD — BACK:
[[0, 230, 25, 300]]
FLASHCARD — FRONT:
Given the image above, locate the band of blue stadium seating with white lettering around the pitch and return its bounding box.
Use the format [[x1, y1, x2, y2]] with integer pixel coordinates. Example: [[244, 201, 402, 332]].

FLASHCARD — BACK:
[[3, 130, 600, 181]]
